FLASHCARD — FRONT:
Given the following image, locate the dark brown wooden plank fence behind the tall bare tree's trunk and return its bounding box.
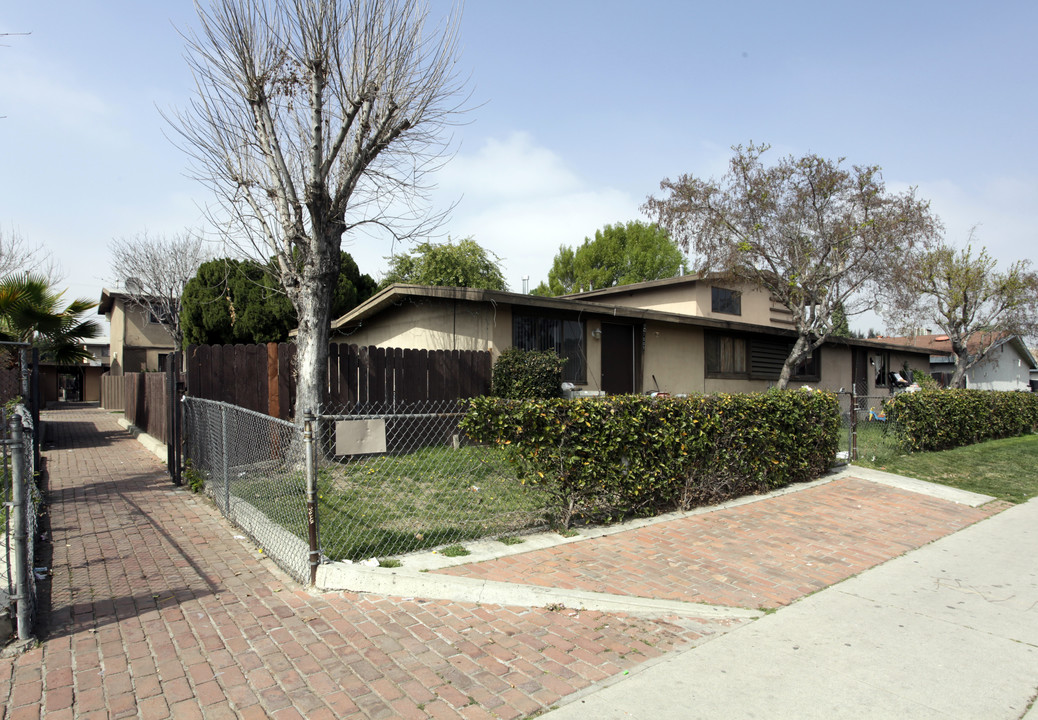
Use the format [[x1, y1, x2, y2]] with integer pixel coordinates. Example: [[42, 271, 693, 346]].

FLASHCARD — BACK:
[[187, 342, 492, 419]]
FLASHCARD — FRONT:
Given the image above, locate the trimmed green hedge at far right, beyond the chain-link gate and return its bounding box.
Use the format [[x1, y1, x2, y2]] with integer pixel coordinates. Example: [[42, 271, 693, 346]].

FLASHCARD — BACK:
[[883, 390, 1038, 452]]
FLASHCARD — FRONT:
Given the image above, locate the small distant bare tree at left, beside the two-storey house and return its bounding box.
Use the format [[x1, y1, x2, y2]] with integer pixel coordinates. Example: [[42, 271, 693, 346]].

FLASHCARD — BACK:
[[108, 231, 210, 348]]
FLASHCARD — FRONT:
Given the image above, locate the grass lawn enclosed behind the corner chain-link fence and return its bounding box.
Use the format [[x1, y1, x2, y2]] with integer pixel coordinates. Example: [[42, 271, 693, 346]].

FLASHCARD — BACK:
[[234, 446, 545, 560]]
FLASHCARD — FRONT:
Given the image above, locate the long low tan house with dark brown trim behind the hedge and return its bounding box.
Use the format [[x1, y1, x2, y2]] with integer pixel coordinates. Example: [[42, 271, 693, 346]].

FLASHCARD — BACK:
[[331, 277, 928, 395]]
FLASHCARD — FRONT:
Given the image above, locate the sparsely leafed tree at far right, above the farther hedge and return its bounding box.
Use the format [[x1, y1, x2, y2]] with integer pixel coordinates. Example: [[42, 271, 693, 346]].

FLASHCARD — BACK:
[[884, 234, 1038, 387]]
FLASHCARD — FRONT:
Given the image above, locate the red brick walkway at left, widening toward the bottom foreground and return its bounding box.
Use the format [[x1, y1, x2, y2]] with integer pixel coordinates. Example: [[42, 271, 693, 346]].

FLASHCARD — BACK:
[[0, 408, 708, 720]]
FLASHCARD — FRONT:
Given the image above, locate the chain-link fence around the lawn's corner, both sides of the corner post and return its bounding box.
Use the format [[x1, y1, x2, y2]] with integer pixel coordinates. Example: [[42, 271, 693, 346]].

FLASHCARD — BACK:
[[184, 397, 546, 582]]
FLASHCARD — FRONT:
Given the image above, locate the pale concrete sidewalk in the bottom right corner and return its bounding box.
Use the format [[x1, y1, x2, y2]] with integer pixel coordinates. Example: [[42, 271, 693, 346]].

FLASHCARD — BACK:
[[544, 499, 1038, 720]]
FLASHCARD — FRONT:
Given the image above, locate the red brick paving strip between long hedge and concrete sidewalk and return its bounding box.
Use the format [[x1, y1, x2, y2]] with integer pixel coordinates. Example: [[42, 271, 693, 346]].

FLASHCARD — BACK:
[[437, 477, 1008, 608]]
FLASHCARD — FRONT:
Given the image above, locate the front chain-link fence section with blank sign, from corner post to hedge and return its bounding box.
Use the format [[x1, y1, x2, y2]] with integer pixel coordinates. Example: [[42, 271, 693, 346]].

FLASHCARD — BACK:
[[317, 400, 546, 560]]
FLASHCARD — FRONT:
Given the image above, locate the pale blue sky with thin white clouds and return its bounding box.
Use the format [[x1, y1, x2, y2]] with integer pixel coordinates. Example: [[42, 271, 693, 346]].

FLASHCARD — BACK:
[[0, 0, 1038, 330]]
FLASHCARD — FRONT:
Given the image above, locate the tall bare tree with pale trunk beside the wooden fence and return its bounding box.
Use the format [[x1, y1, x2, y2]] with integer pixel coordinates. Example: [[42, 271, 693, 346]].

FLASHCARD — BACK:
[[172, 0, 464, 421]]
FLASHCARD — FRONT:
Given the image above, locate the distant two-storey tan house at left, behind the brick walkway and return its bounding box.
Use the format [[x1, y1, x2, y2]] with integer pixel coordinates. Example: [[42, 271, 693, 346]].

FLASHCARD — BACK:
[[98, 289, 174, 376]]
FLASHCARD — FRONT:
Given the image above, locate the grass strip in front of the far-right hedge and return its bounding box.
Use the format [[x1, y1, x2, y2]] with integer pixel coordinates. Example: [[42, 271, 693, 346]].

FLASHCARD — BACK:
[[857, 431, 1038, 503]]
